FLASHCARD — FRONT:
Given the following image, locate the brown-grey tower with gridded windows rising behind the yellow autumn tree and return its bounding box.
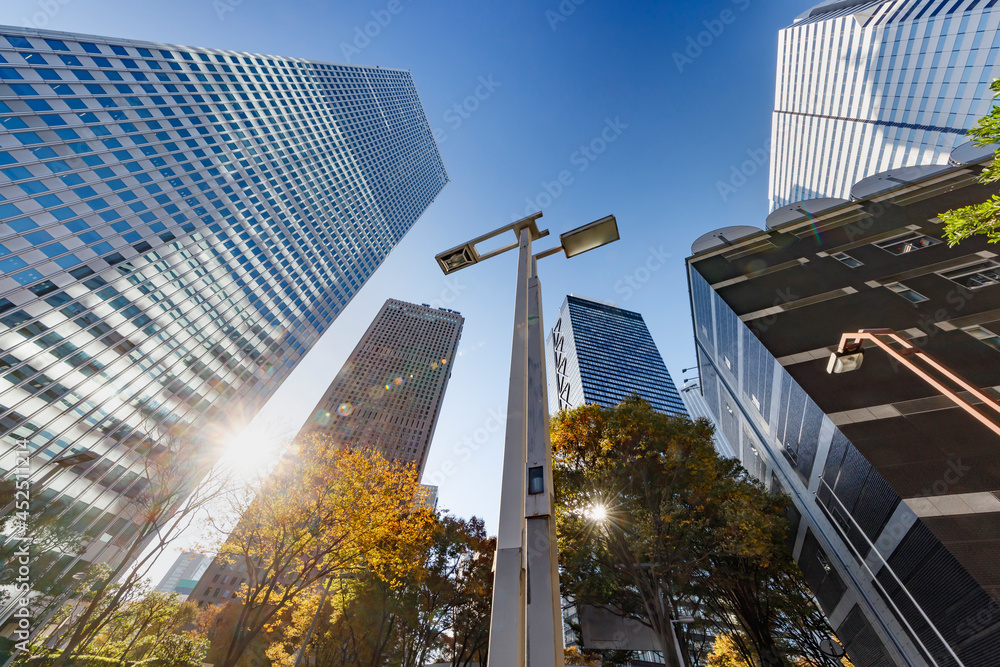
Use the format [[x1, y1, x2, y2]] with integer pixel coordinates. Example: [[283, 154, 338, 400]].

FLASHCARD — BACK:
[[191, 299, 465, 604]]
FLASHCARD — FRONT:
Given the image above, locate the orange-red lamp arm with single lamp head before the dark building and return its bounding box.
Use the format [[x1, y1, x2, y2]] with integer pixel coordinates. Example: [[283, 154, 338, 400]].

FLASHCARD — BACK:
[[826, 329, 1000, 435]]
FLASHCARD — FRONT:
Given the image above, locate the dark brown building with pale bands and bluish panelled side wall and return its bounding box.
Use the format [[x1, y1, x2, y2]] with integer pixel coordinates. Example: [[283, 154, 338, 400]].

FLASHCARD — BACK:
[[688, 154, 1000, 667]]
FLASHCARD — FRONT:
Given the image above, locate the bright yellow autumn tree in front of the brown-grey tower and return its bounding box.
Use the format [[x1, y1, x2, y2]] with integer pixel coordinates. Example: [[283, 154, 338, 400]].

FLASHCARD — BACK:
[[209, 436, 433, 667]]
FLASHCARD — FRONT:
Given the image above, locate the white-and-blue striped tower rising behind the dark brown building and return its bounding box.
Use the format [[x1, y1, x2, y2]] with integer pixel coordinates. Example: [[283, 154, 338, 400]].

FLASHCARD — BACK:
[[768, 0, 1000, 210]]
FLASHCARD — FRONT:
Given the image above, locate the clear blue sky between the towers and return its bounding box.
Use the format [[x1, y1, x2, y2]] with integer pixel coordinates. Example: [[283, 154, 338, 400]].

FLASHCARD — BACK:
[[0, 0, 815, 572]]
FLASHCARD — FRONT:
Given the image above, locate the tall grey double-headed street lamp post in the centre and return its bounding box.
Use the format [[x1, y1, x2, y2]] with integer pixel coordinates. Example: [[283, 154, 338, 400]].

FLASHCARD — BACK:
[[435, 211, 619, 667]]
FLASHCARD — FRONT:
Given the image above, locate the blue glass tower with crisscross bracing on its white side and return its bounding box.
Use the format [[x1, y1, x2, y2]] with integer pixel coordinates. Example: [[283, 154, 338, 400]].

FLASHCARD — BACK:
[[545, 295, 687, 415]]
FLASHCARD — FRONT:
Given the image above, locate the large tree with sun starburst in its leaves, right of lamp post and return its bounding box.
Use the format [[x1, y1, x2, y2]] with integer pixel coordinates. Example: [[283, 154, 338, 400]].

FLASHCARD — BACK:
[[552, 398, 760, 667]]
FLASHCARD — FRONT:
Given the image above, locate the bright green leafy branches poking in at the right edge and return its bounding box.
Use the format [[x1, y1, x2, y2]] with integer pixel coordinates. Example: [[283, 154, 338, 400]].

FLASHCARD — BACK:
[[938, 79, 1000, 246]]
